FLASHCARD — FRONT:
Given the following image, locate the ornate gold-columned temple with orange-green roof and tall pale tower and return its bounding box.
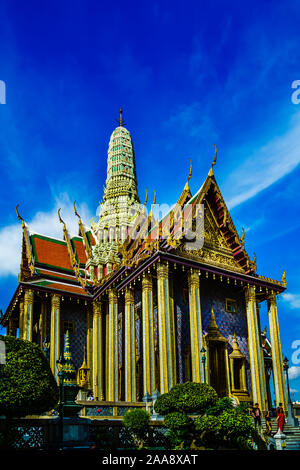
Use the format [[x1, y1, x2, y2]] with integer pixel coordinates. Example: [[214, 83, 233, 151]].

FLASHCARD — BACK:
[[1, 112, 287, 410]]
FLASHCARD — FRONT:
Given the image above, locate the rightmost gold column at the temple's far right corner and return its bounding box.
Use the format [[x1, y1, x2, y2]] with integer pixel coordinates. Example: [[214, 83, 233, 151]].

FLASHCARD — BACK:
[[268, 292, 288, 410]]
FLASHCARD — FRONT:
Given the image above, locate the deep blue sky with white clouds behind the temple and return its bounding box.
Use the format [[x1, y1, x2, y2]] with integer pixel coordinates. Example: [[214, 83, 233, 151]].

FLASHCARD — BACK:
[[0, 0, 300, 400]]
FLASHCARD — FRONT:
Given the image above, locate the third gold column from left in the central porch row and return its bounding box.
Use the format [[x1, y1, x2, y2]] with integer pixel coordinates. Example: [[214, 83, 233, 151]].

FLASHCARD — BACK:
[[125, 287, 136, 402]]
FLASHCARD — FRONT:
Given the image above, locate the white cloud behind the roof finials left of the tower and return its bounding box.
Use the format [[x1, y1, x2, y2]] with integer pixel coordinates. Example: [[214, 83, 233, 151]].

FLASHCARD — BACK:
[[0, 193, 91, 277]]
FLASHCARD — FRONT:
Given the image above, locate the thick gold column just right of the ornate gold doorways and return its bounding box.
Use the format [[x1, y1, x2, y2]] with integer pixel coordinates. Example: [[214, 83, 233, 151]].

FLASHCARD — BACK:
[[245, 286, 267, 410]]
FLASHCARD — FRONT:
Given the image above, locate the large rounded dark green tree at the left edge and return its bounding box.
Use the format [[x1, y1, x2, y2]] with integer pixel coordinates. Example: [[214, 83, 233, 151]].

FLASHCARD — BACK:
[[0, 336, 59, 417]]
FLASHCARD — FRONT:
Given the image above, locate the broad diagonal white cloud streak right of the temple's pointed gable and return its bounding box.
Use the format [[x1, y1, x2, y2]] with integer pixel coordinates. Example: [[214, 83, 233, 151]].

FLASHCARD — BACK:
[[224, 113, 300, 208]]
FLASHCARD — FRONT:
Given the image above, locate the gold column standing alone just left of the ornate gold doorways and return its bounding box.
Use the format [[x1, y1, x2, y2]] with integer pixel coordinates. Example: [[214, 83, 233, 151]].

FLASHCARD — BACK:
[[188, 269, 204, 382]]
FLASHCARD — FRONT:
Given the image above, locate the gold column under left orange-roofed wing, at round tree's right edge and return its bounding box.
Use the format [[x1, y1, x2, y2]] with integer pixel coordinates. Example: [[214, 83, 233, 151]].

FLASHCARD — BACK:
[[50, 294, 60, 379]]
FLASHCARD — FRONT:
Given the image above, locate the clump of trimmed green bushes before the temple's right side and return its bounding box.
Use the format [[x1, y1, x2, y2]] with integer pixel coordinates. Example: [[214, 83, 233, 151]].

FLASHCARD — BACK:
[[154, 382, 257, 449]]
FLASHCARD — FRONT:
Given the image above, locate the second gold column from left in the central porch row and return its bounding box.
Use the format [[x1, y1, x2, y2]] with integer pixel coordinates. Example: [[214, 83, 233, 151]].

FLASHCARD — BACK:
[[106, 289, 119, 401]]
